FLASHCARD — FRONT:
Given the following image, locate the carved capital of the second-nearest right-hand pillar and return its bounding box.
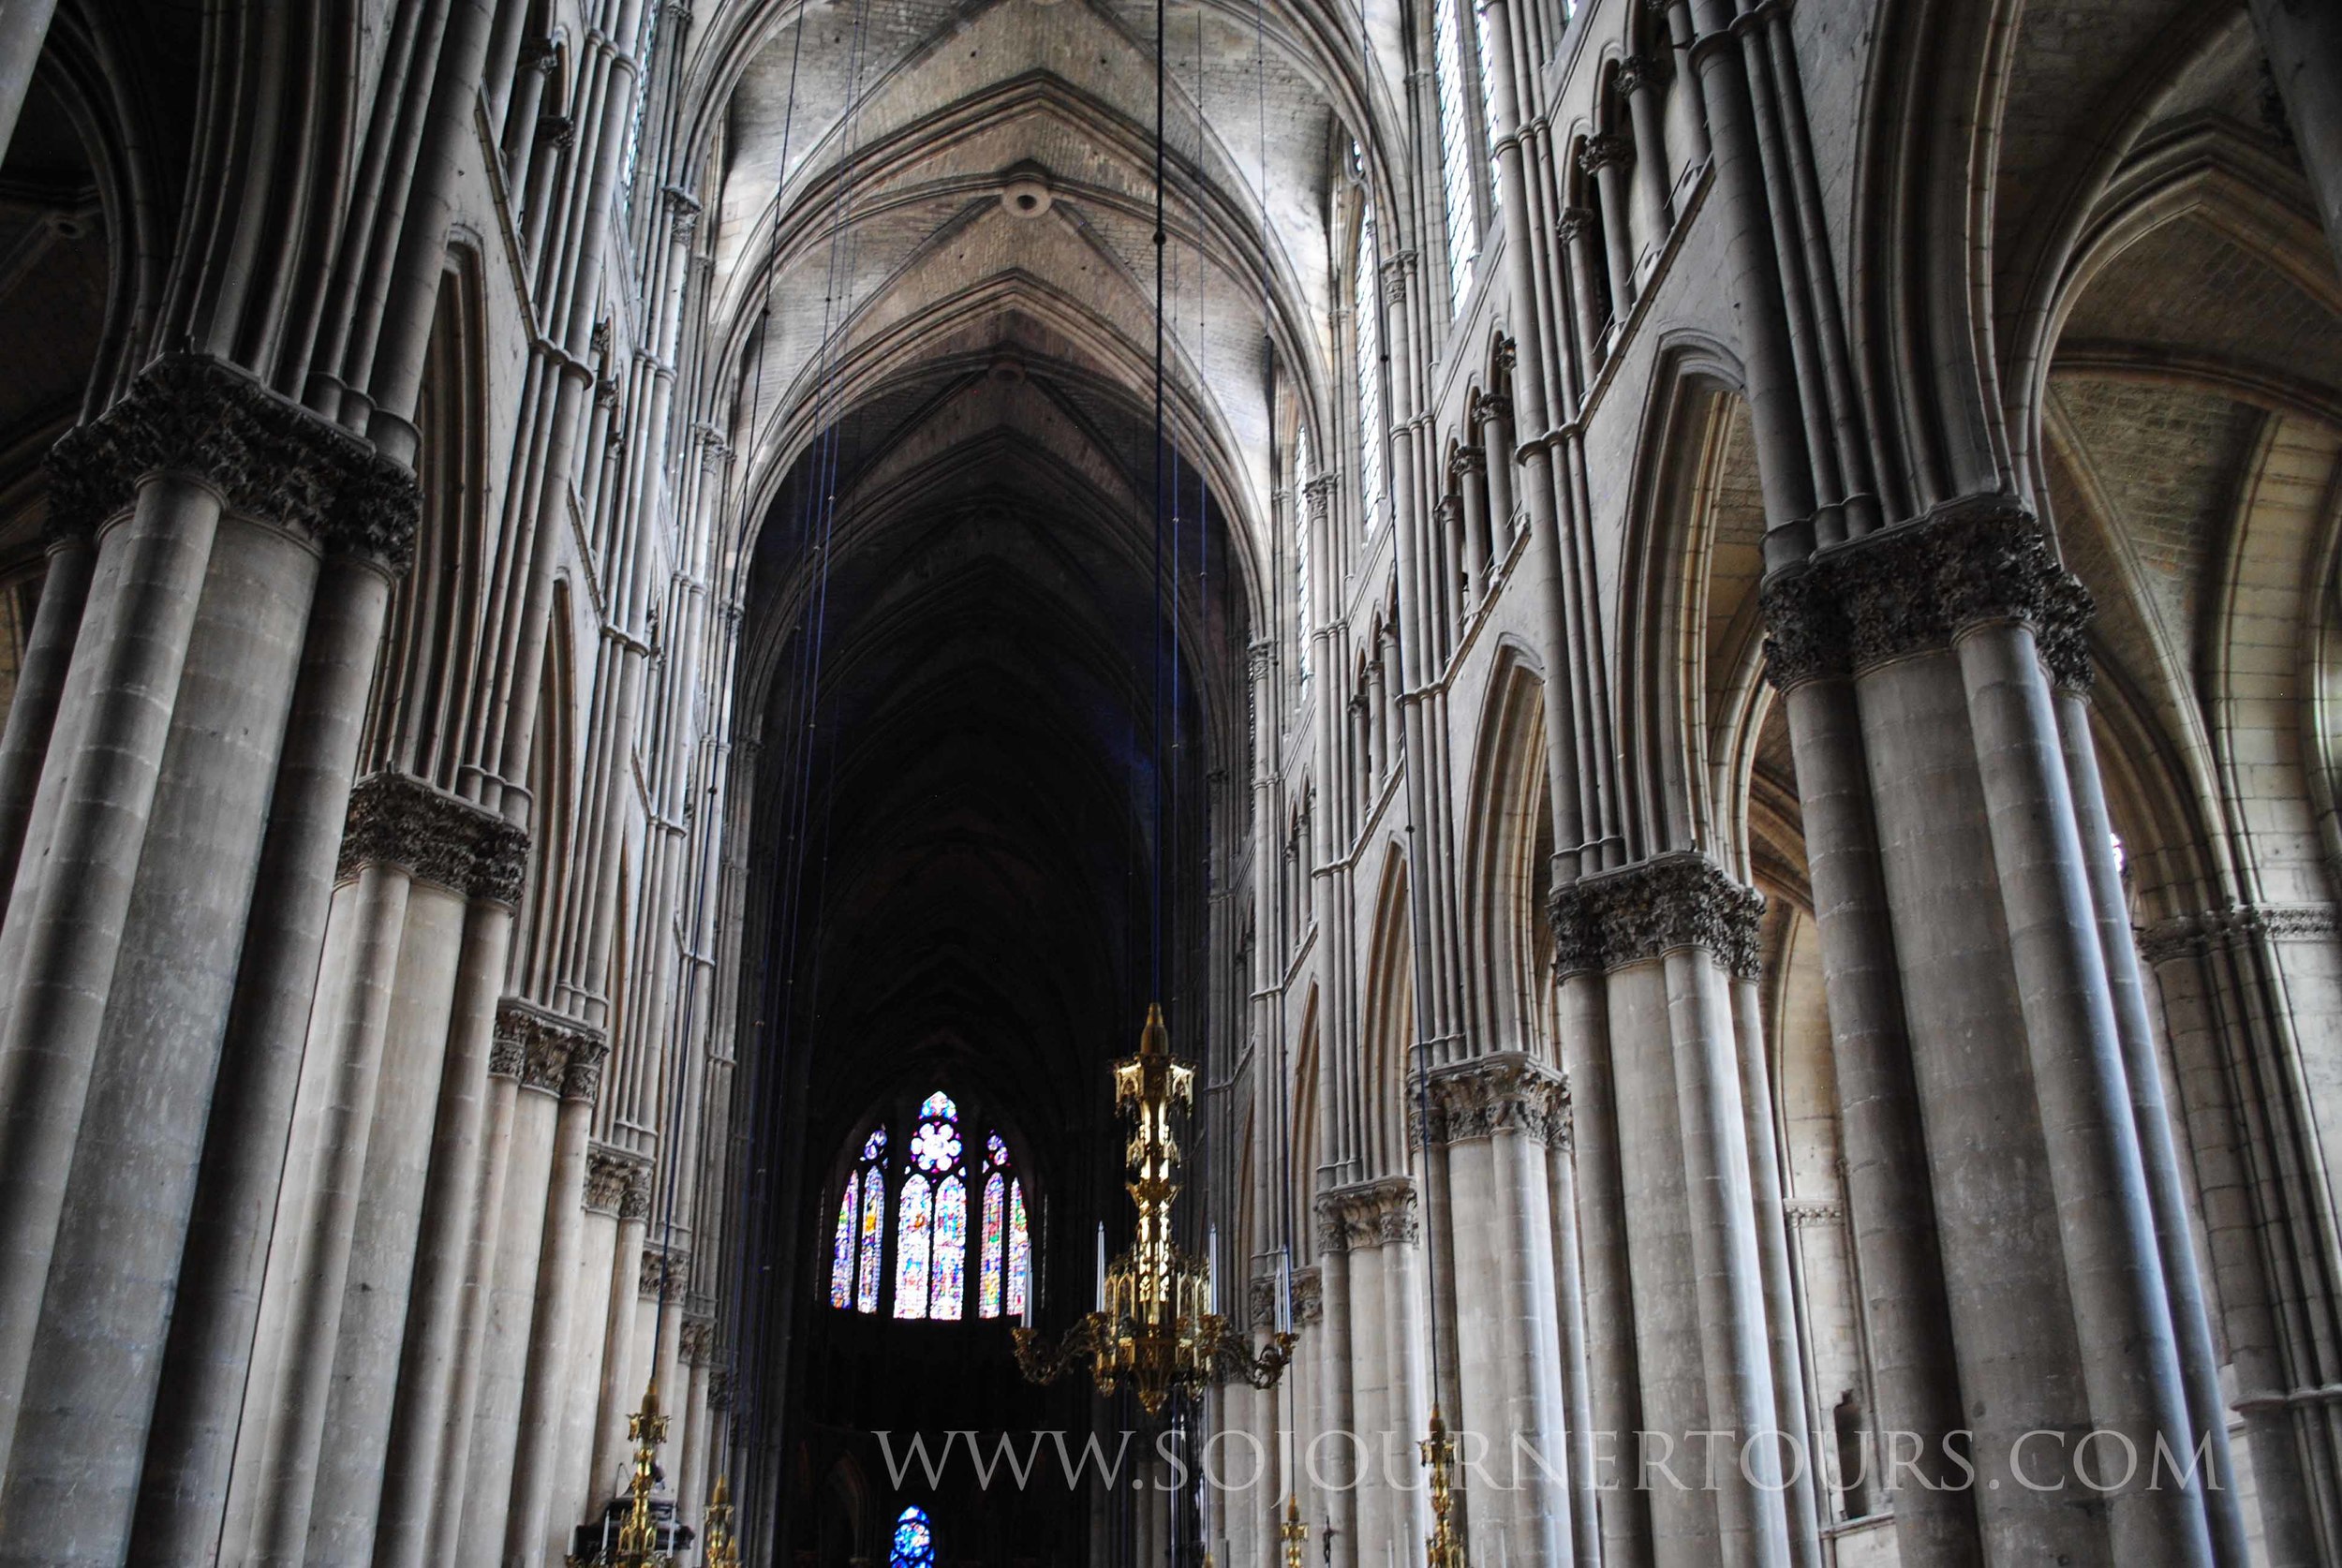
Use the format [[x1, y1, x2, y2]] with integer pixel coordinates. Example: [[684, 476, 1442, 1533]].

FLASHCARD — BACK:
[[1549, 850, 1764, 978]]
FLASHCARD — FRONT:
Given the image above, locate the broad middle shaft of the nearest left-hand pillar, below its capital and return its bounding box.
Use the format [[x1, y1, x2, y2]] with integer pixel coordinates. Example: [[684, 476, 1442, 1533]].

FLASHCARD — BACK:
[[0, 517, 317, 1563]]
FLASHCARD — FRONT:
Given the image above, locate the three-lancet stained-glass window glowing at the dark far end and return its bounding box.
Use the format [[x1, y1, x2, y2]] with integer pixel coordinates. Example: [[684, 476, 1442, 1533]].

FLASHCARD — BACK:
[[829, 1090, 1033, 1323]]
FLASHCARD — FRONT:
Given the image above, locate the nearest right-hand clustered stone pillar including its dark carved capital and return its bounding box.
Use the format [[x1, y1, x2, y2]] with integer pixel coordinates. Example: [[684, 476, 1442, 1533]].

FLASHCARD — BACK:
[[1766, 496, 2209, 1563]]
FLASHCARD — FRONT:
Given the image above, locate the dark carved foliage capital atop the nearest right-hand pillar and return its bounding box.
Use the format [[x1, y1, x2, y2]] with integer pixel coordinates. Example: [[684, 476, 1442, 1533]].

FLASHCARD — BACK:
[[1759, 496, 2094, 690]]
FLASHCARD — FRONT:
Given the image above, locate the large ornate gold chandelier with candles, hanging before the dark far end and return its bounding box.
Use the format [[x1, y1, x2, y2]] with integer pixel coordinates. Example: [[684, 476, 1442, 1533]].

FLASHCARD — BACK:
[[1015, 1004, 1293, 1416]]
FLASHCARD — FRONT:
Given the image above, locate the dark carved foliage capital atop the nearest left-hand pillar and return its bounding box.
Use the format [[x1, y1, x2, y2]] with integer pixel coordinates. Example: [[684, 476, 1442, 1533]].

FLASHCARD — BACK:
[[47, 353, 422, 573]]
